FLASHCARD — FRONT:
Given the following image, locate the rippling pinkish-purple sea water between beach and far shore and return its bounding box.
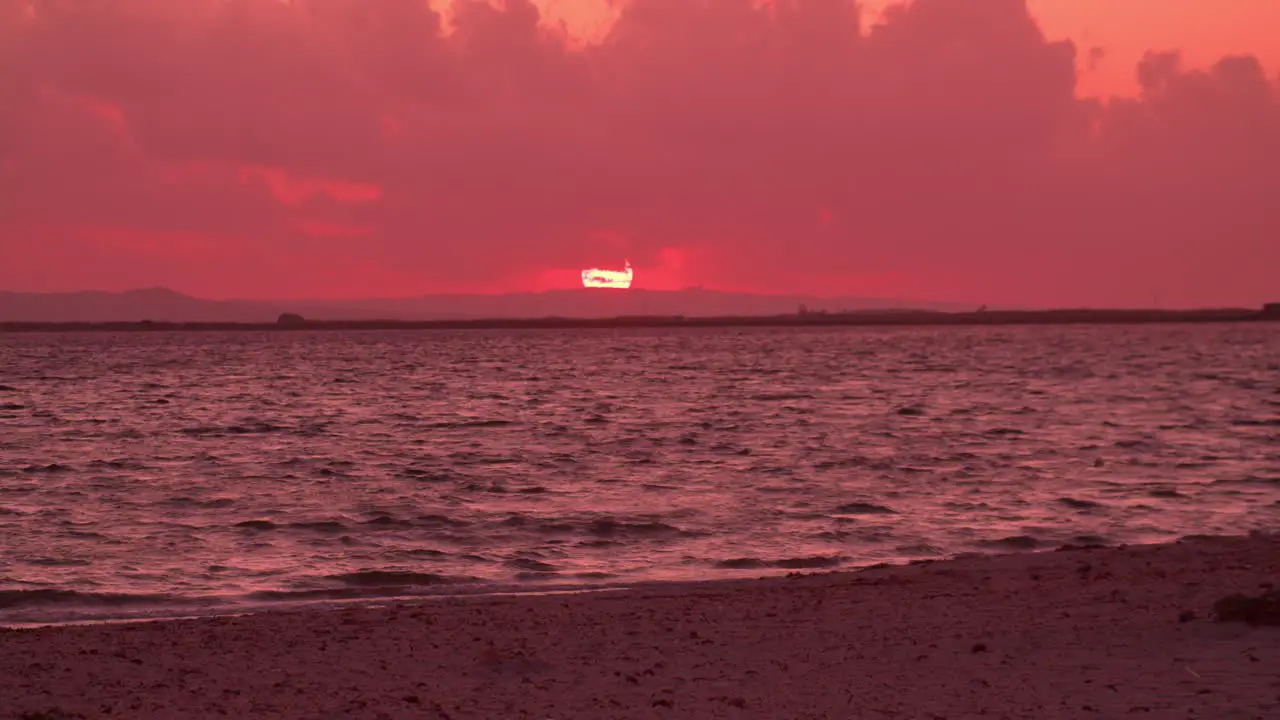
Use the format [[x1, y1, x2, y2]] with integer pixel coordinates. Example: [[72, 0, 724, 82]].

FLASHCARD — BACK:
[[0, 324, 1280, 623]]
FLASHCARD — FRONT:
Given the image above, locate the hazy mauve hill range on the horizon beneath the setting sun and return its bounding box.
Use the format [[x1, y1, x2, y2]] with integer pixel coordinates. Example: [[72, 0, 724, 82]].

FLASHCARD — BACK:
[[0, 288, 972, 323]]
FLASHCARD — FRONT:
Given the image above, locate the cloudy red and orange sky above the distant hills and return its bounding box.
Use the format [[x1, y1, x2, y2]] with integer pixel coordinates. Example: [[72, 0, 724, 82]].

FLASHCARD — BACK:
[[0, 0, 1280, 306]]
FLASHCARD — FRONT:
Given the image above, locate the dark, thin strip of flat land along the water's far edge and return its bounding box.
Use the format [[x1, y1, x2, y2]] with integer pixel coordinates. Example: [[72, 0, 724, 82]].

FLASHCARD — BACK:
[[0, 305, 1280, 333]]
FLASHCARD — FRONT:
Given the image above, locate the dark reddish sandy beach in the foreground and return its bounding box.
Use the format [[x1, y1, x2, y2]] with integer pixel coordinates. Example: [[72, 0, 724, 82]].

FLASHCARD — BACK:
[[0, 537, 1280, 720]]
